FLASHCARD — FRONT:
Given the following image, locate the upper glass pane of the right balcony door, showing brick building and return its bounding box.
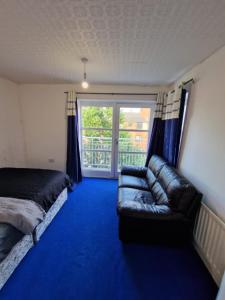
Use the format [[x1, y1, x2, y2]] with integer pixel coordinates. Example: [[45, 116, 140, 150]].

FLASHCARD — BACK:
[[119, 107, 151, 130]]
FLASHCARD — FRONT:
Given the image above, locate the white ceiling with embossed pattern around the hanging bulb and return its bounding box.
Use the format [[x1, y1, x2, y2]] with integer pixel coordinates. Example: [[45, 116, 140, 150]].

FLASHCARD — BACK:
[[0, 0, 225, 84]]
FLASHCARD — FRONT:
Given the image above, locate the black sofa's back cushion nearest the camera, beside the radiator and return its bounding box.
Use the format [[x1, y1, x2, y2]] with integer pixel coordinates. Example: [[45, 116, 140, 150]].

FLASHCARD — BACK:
[[158, 165, 197, 213]]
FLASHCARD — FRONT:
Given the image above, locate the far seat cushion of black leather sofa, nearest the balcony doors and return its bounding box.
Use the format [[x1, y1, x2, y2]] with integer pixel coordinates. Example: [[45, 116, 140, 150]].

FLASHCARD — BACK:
[[119, 175, 149, 191]]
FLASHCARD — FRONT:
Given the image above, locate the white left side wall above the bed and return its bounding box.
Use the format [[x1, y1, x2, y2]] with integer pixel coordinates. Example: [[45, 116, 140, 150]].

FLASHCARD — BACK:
[[0, 78, 25, 167]]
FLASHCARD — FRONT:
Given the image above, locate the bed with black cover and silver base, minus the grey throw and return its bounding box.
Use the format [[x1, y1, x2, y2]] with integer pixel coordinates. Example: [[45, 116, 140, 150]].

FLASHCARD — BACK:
[[0, 168, 71, 289]]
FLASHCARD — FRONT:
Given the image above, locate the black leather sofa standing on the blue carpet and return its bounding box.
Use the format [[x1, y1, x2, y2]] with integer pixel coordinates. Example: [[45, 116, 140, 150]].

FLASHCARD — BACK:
[[117, 155, 202, 243]]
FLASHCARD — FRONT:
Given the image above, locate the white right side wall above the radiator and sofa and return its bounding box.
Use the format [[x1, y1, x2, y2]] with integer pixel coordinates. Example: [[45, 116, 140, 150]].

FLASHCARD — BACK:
[[177, 47, 225, 220]]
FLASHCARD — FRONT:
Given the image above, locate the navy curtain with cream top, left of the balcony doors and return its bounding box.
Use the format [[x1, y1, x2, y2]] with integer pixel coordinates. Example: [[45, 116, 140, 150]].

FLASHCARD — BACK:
[[66, 92, 82, 183]]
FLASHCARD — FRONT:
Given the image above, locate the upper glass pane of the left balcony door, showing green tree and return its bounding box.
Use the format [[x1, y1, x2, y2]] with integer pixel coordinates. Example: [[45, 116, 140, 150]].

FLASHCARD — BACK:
[[81, 106, 113, 128]]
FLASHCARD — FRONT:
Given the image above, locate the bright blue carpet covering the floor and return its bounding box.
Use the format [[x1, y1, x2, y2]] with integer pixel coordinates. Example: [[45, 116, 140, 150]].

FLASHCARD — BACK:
[[0, 179, 217, 300]]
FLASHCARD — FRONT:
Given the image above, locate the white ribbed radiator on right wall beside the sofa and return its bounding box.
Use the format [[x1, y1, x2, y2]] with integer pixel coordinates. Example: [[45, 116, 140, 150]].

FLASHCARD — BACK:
[[194, 203, 225, 285]]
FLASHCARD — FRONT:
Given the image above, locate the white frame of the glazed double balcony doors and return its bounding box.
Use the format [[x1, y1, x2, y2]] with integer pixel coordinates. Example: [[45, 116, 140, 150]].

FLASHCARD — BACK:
[[77, 98, 156, 178]]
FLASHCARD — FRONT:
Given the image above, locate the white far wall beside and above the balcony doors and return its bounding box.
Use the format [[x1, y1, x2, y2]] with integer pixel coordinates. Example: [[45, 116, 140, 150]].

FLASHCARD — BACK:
[[20, 84, 159, 170]]
